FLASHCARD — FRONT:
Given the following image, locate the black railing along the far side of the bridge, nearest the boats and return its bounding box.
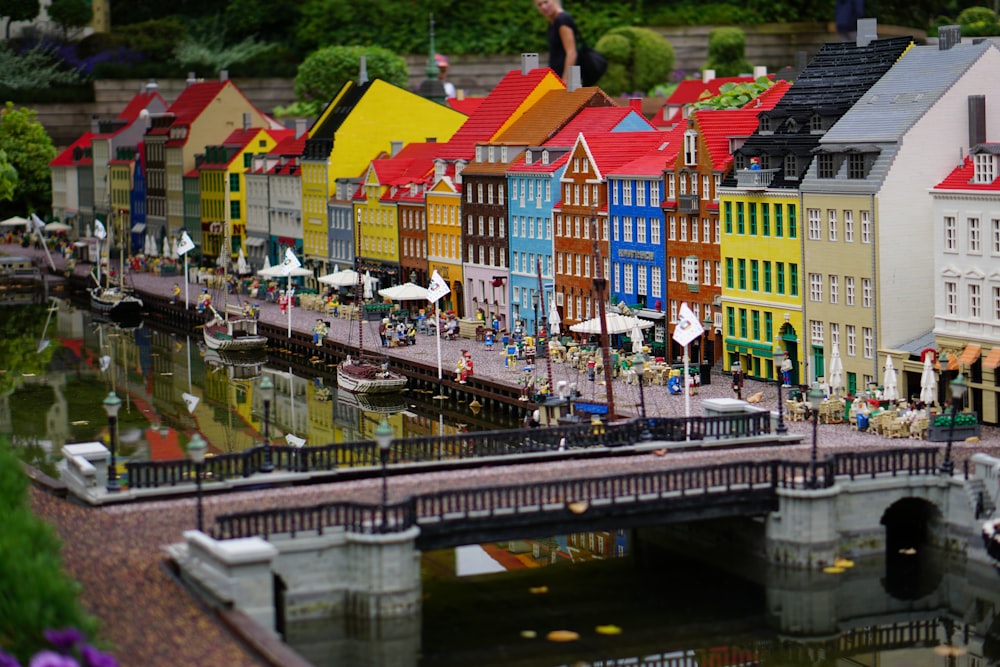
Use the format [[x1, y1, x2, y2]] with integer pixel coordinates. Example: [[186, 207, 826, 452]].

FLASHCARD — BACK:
[[125, 413, 771, 489]]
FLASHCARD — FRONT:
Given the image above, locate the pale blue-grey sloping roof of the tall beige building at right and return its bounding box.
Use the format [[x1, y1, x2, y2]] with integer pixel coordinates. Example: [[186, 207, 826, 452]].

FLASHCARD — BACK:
[[820, 42, 997, 144]]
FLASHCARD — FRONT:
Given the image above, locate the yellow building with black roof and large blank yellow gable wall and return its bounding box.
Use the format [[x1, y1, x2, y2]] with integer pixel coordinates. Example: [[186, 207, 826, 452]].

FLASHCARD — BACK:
[[302, 79, 466, 272]]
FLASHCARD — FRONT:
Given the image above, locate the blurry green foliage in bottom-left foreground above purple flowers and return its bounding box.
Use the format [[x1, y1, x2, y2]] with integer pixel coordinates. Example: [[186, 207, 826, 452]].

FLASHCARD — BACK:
[[0, 438, 97, 664]]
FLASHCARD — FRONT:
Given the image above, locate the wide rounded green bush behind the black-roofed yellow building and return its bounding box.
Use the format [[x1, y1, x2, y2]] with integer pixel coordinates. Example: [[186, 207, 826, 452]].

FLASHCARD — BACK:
[[294, 46, 409, 116]]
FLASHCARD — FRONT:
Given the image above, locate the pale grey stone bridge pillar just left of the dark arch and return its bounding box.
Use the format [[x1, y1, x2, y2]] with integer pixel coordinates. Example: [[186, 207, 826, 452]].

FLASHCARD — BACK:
[[766, 484, 841, 569]]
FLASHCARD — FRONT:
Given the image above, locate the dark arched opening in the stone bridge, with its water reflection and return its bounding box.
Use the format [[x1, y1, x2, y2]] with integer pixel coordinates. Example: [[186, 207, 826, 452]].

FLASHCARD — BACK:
[[879, 496, 944, 600]]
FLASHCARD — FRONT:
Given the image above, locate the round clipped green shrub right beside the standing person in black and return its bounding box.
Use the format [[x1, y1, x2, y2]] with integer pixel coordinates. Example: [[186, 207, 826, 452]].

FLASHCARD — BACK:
[[594, 27, 674, 96]]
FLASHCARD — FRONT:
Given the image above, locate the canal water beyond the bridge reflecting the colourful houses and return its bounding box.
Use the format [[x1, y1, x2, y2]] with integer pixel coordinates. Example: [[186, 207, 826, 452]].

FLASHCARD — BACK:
[[0, 302, 513, 472]]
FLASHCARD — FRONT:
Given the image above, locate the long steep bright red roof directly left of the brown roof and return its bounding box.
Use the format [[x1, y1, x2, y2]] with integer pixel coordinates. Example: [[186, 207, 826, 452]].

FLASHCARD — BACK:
[[440, 68, 554, 160]]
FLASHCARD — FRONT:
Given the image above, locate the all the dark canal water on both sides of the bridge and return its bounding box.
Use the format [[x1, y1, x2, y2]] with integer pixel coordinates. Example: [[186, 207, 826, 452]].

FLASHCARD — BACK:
[[0, 306, 1000, 667]]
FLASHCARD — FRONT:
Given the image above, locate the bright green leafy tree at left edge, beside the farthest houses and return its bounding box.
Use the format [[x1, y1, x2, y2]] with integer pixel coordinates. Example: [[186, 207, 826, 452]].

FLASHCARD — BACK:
[[0, 102, 56, 217]]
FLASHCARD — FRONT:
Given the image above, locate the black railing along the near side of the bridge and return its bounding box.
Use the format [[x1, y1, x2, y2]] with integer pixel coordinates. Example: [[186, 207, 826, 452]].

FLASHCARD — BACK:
[[211, 449, 937, 539]]
